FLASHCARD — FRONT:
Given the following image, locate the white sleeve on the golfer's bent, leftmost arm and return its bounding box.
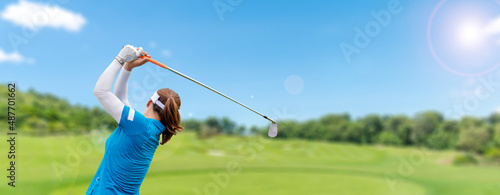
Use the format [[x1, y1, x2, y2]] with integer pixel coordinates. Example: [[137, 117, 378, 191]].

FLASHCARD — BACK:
[[94, 60, 124, 123]]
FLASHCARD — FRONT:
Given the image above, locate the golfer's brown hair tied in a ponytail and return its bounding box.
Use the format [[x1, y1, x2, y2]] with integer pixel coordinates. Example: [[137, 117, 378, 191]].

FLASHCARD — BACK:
[[153, 88, 184, 145]]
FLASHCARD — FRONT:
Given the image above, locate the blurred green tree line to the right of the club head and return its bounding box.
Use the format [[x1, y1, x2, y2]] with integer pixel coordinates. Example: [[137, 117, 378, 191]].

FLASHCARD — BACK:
[[260, 111, 500, 158]]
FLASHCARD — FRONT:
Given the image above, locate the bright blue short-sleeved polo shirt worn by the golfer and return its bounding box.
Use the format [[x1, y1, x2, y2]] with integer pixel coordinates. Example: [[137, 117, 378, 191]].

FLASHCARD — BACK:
[[86, 106, 165, 195]]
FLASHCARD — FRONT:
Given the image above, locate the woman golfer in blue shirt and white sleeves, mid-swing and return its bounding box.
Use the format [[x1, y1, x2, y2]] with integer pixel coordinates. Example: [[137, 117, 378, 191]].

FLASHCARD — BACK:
[[86, 45, 183, 195]]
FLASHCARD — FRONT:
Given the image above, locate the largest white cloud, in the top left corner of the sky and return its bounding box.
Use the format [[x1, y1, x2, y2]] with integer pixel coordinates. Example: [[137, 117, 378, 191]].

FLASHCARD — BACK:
[[1, 0, 86, 32]]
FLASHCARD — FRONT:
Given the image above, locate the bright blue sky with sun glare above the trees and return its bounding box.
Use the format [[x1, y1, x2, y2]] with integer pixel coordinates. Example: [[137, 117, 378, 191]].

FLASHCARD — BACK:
[[0, 0, 500, 125]]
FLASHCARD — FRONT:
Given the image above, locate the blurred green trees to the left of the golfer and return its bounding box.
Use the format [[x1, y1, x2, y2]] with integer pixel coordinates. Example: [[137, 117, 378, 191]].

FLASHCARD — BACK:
[[0, 84, 116, 135]]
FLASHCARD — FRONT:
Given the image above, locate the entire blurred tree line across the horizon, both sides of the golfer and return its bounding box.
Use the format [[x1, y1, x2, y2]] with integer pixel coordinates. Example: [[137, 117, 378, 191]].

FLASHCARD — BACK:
[[0, 85, 500, 158]]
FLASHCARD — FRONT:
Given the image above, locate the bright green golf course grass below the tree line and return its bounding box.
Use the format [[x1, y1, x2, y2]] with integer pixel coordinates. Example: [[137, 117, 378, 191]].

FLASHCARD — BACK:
[[0, 133, 500, 195]]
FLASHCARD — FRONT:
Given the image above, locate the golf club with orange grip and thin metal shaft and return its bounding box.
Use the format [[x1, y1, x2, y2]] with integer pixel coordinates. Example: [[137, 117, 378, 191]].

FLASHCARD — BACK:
[[140, 56, 278, 137]]
